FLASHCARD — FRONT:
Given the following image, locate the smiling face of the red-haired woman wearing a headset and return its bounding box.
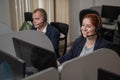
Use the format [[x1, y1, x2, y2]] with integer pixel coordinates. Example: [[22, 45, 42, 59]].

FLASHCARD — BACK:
[[81, 18, 96, 38]]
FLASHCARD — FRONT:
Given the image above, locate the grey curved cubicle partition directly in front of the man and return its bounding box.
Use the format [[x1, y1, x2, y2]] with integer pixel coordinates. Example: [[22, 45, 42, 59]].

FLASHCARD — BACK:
[[0, 30, 54, 56]]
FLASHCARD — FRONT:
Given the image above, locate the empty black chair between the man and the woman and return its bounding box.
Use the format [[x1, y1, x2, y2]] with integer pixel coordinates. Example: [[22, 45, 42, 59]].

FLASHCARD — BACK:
[[50, 22, 69, 55]]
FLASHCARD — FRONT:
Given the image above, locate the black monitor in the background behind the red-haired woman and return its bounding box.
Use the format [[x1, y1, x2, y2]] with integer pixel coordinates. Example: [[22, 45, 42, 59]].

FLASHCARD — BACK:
[[101, 5, 120, 23]]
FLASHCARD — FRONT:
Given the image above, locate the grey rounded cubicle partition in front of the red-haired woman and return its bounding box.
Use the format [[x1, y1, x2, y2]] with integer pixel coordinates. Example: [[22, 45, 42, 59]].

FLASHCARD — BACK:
[[60, 49, 120, 80]]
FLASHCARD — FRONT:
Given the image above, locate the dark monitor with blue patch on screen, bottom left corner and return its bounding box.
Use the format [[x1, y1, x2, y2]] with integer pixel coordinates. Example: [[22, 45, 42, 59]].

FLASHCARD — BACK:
[[0, 50, 25, 80]]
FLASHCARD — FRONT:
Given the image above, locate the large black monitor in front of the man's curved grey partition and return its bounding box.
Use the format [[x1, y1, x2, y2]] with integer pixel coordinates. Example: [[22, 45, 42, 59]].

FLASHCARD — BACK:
[[13, 38, 57, 71]]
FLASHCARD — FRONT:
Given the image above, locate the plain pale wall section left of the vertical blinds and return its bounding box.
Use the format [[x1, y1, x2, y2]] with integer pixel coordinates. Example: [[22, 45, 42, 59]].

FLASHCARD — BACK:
[[0, 0, 10, 26]]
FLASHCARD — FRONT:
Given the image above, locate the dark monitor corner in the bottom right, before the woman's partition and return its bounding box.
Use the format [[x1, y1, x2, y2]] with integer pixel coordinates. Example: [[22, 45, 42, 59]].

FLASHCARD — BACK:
[[98, 68, 120, 80]]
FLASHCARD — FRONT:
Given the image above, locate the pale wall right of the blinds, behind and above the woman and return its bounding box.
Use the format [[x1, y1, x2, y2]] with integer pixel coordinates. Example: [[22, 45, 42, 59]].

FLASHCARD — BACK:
[[69, 0, 120, 41]]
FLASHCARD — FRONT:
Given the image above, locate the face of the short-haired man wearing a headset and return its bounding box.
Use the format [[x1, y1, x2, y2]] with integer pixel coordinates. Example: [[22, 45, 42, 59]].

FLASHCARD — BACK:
[[32, 11, 43, 28]]
